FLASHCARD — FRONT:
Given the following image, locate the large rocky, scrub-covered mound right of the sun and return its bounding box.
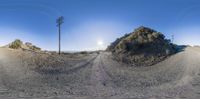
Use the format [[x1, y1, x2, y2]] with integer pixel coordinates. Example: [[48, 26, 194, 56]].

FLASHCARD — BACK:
[[107, 26, 176, 66]]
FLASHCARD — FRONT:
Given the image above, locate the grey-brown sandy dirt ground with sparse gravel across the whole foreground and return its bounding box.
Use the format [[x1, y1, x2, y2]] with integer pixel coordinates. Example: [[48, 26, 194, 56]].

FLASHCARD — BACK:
[[0, 47, 200, 99]]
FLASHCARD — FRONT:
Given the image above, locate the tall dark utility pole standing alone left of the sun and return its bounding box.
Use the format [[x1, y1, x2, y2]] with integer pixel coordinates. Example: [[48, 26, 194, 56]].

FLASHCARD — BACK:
[[56, 16, 64, 55]]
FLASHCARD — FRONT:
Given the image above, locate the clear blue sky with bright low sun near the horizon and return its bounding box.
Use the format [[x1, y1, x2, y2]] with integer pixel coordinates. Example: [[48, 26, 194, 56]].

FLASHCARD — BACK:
[[0, 0, 200, 51]]
